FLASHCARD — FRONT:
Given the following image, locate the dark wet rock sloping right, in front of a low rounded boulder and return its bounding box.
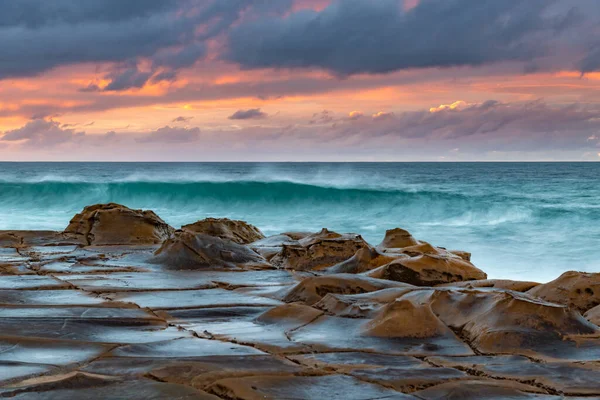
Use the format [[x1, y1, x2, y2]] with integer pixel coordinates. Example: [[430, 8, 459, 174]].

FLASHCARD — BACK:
[[150, 230, 271, 270]]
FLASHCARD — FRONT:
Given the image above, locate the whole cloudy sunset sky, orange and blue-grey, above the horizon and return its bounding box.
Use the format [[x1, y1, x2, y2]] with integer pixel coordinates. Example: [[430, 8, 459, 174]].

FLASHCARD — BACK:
[[0, 0, 600, 161]]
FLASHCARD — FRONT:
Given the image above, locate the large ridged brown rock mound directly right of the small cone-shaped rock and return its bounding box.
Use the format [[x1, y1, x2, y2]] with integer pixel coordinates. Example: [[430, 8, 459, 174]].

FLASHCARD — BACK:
[[420, 288, 600, 360]]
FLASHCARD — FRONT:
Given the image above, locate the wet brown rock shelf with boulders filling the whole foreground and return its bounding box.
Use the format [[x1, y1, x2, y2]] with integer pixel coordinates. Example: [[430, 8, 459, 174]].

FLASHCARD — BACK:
[[0, 212, 600, 400]]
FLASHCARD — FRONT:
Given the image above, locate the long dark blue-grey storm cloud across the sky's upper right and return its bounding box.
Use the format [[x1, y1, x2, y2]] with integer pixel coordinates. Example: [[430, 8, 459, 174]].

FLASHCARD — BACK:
[[226, 0, 600, 75]]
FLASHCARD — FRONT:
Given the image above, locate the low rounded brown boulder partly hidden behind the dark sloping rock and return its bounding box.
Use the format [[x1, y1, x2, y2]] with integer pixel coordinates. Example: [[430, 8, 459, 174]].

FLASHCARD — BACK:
[[181, 218, 265, 244]]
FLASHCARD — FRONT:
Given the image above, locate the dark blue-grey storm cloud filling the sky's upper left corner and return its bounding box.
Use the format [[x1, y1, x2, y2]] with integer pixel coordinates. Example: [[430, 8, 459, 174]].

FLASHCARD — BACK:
[[0, 0, 291, 83]]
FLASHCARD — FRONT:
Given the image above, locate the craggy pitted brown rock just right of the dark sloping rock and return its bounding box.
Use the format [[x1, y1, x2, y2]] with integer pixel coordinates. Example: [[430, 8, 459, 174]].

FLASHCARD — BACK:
[[271, 229, 369, 271]]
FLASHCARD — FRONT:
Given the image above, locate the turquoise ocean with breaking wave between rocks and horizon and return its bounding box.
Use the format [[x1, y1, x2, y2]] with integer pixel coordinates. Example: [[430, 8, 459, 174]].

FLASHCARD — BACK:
[[0, 163, 600, 282]]
